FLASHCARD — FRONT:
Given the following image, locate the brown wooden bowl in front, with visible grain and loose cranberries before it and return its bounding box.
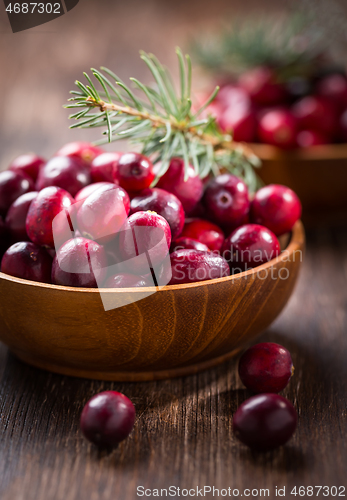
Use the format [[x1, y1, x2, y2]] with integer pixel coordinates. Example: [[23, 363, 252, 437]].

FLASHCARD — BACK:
[[0, 222, 305, 381]]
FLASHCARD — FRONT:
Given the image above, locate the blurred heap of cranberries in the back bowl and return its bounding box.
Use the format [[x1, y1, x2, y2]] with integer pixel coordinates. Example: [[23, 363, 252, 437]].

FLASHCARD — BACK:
[[208, 67, 347, 149]]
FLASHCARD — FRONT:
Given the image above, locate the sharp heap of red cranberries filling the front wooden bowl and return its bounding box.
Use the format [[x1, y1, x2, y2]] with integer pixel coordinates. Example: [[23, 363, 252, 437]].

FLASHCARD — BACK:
[[0, 142, 301, 288]]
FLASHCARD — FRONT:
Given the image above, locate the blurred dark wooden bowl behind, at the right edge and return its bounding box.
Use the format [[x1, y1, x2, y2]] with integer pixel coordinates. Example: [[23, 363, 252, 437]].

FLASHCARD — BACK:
[[250, 144, 347, 225]]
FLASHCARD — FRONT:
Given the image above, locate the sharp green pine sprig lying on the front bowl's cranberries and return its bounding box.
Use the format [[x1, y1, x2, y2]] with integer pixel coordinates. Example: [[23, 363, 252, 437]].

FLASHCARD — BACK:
[[66, 49, 259, 191]]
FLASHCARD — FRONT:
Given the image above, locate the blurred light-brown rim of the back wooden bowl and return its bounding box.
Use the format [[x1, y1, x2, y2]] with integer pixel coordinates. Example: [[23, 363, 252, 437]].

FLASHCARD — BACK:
[[247, 142, 347, 161]]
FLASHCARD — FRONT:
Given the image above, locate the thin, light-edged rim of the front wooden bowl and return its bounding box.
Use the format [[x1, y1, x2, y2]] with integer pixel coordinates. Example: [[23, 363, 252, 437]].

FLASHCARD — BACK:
[[0, 221, 305, 294]]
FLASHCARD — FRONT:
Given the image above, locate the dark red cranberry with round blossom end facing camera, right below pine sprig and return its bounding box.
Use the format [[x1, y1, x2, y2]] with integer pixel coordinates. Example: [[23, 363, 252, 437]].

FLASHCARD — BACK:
[[203, 174, 250, 230]]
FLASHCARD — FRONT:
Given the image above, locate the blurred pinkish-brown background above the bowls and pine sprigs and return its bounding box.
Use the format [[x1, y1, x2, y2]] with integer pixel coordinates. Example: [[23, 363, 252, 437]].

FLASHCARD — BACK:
[[0, 0, 347, 169]]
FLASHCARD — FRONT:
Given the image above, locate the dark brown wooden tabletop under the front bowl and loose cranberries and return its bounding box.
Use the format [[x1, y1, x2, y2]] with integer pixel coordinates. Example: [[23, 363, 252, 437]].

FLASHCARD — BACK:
[[0, 229, 347, 500]]
